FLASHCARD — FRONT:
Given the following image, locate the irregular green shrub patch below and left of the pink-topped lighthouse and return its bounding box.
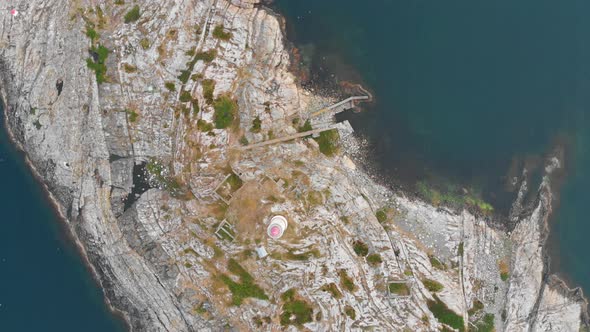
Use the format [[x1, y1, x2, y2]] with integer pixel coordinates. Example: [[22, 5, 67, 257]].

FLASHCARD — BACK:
[[221, 259, 268, 306]]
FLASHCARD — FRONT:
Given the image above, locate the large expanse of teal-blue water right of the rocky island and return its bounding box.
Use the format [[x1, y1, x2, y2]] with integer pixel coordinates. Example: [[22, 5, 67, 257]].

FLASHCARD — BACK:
[[274, 0, 590, 293]]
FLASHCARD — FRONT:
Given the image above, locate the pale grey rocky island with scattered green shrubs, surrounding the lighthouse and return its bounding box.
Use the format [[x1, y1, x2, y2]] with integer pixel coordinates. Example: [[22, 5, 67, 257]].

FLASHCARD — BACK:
[[0, 0, 589, 331]]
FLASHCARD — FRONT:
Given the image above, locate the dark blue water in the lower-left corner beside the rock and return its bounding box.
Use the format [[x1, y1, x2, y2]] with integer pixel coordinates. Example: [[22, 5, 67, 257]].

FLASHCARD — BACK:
[[0, 106, 125, 332]]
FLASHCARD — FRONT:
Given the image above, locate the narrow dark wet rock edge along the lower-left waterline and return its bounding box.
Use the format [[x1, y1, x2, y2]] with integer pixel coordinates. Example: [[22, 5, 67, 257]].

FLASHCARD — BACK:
[[0, 89, 132, 331]]
